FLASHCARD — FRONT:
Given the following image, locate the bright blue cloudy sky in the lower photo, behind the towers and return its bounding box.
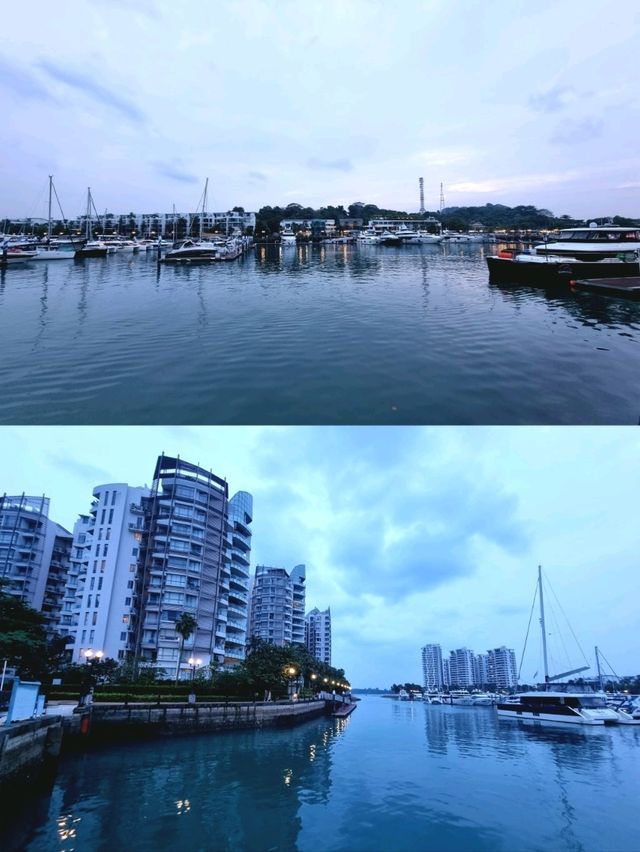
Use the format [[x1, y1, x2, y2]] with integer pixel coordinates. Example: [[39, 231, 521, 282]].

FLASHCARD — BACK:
[[0, 426, 640, 688]]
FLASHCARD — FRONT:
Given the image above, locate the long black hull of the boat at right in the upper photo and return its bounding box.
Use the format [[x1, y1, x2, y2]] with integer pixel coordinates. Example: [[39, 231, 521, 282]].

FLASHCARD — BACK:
[[487, 256, 640, 287]]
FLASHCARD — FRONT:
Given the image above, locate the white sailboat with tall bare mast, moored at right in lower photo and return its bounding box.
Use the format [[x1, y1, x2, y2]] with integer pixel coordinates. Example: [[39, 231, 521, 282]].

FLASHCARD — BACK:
[[496, 566, 620, 725]]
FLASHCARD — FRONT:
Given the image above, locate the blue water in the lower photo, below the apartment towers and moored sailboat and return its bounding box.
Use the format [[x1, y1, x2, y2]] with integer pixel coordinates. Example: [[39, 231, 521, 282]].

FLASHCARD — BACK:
[[4, 697, 640, 852]]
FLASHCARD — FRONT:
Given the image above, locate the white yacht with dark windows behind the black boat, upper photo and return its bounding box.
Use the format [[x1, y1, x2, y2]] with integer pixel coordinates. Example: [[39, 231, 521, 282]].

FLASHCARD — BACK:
[[534, 222, 640, 261]]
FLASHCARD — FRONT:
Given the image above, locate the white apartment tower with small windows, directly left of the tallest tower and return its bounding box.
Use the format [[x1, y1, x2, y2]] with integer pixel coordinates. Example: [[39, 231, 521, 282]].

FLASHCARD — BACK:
[[69, 482, 149, 663]]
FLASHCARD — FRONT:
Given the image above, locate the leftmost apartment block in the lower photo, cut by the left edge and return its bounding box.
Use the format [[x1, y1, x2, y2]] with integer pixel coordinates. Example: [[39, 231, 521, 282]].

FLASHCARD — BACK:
[[0, 494, 72, 635]]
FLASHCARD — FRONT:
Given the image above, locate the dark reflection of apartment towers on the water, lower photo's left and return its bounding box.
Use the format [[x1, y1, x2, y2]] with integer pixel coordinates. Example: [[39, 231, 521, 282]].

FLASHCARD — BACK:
[[1, 719, 350, 852]]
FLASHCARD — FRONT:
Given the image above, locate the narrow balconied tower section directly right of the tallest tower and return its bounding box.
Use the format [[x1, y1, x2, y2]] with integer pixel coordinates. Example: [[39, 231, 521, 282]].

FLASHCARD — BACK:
[[224, 491, 253, 667]]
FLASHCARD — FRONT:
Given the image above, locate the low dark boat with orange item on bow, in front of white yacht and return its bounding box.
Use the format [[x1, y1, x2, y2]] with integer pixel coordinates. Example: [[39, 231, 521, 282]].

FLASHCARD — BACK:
[[486, 249, 640, 286]]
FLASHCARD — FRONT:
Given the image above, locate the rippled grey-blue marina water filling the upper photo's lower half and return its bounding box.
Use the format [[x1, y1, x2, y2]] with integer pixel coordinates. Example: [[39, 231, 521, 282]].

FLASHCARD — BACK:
[[0, 246, 640, 424]]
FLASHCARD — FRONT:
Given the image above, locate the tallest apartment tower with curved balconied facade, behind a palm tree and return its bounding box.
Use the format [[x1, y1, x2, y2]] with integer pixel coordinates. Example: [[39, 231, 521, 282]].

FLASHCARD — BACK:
[[136, 455, 231, 678]]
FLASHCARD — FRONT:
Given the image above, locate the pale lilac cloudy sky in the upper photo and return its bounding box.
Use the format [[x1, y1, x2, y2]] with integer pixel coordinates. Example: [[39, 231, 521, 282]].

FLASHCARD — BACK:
[[0, 0, 640, 218]]
